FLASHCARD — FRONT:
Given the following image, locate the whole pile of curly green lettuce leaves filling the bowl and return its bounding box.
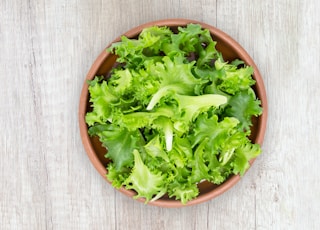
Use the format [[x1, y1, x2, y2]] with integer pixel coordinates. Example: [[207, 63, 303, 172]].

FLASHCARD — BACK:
[[86, 24, 262, 204]]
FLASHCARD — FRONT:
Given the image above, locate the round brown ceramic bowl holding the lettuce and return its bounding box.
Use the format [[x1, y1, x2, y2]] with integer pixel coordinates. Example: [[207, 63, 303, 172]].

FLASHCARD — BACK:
[[79, 19, 268, 207]]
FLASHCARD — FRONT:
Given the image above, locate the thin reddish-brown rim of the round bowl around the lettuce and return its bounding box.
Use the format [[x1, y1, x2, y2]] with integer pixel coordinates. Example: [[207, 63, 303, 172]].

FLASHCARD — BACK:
[[78, 18, 268, 208]]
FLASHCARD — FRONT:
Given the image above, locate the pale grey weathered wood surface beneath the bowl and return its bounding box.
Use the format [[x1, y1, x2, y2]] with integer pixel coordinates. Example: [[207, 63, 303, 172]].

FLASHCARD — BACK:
[[0, 0, 320, 230]]
